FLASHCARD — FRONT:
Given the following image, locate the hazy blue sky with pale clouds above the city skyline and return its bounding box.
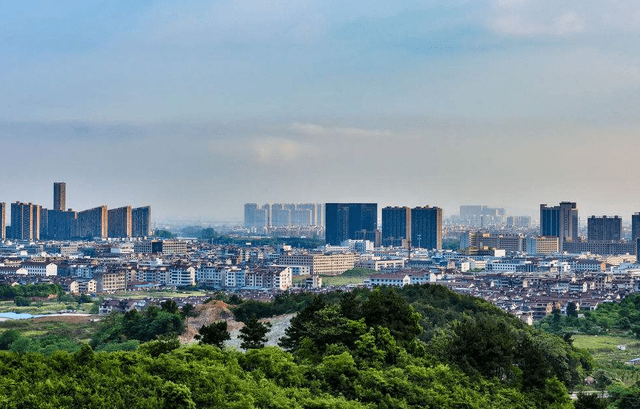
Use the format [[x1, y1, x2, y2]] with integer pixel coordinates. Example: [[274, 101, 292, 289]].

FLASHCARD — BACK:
[[0, 0, 640, 221]]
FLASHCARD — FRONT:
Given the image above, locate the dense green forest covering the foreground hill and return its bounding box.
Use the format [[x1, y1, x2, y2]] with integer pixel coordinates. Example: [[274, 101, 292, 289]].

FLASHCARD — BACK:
[[0, 284, 640, 409]]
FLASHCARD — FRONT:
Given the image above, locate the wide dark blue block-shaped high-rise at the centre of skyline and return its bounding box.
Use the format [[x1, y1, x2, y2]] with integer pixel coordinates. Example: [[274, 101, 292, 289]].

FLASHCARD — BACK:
[[325, 203, 378, 246]]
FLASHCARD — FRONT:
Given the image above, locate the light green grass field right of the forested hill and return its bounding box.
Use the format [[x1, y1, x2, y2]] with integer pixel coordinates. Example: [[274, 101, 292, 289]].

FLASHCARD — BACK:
[[573, 335, 640, 386]]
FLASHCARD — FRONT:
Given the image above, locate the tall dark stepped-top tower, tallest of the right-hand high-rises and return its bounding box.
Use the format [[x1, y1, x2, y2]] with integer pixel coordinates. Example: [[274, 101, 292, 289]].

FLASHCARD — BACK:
[[540, 202, 578, 251]]
